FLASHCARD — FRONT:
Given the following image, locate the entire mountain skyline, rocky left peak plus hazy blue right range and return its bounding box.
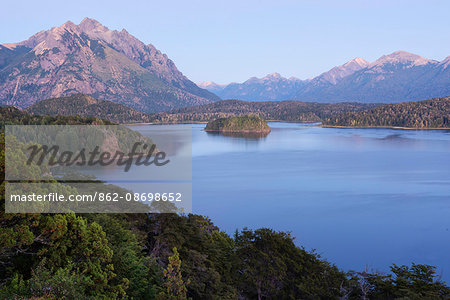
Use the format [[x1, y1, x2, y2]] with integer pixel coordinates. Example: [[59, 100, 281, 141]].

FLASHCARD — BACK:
[[0, 18, 450, 113]]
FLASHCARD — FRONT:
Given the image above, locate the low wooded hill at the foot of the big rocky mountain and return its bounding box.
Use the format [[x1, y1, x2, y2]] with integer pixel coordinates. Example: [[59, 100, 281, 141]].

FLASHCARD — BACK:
[[25, 94, 150, 123]]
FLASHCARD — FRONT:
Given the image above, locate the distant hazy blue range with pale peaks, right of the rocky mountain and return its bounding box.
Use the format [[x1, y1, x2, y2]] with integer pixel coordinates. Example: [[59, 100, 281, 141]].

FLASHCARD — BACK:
[[199, 51, 450, 103]]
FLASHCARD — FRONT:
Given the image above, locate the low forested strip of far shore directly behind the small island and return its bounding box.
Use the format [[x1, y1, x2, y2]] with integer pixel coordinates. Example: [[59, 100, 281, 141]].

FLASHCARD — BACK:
[[151, 100, 379, 123]]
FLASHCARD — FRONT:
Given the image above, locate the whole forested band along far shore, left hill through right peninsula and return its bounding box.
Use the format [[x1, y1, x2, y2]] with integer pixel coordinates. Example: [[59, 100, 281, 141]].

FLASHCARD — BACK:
[[22, 94, 450, 129]]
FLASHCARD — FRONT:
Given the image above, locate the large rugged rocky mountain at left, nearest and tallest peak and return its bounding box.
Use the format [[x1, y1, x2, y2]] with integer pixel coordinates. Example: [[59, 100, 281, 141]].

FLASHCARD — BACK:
[[0, 18, 219, 112]]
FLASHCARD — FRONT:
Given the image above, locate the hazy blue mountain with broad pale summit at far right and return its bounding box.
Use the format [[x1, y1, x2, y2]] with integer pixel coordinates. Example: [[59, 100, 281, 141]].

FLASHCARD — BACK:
[[295, 51, 450, 103]]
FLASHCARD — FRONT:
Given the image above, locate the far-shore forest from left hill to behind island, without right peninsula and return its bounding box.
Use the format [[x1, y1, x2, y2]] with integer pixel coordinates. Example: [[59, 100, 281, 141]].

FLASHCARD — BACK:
[[22, 94, 379, 123]]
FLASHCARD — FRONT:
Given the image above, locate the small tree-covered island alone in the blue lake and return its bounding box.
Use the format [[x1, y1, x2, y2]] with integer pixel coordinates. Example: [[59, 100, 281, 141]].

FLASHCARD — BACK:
[[205, 115, 270, 135]]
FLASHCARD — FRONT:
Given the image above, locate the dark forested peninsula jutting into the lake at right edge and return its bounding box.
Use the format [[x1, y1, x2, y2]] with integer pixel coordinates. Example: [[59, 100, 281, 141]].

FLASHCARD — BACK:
[[323, 97, 450, 129]]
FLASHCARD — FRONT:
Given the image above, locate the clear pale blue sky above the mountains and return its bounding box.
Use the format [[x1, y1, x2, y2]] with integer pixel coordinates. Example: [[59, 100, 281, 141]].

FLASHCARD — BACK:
[[0, 0, 450, 83]]
